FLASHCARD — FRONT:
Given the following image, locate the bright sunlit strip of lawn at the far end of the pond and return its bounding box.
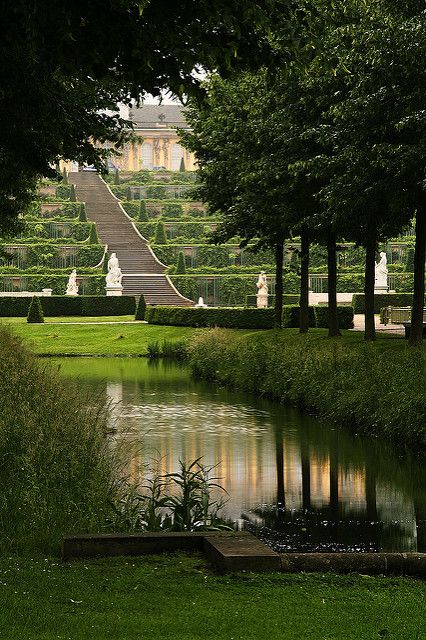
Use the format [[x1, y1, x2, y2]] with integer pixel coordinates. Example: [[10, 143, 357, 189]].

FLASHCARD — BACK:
[[4, 318, 200, 355]]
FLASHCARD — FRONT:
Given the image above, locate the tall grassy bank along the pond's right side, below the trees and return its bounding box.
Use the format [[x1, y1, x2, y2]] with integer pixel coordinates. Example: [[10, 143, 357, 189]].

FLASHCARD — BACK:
[[191, 329, 426, 449]]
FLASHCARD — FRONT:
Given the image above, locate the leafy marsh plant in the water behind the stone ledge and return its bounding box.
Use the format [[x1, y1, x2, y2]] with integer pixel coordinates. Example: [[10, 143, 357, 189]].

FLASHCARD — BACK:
[[111, 458, 232, 531]]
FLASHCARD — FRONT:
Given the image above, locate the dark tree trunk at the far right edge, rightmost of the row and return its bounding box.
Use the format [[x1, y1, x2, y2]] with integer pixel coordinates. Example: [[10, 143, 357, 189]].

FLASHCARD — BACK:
[[409, 202, 426, 347]]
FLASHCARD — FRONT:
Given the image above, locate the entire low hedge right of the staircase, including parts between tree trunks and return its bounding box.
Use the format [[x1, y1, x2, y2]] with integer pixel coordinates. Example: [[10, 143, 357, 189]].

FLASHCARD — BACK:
[[145, 305, 354, 329]]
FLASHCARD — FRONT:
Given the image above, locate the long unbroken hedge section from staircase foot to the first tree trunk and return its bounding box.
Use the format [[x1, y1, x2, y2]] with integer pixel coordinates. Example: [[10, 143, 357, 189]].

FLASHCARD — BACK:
[[145, 305, 274, 329]]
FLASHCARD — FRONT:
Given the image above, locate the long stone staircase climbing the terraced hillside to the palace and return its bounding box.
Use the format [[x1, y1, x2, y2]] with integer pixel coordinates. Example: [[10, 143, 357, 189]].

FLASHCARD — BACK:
[[69, 171, 194, 307]]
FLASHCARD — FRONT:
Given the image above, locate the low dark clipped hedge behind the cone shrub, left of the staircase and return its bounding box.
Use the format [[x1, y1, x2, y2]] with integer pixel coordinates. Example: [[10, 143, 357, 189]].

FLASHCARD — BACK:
[[0, 296, 136, 318]]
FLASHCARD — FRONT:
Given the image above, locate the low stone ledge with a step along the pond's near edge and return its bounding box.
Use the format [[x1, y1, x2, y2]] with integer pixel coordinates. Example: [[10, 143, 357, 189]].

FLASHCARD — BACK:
[[62, 531, 426, 578]]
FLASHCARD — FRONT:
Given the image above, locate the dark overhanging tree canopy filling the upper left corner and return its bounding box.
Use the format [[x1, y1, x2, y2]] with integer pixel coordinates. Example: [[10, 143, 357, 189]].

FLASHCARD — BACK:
[[0, 0, 285, 229]]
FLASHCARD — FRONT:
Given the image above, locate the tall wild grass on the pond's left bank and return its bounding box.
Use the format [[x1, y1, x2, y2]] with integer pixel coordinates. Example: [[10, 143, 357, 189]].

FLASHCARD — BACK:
[[0, 327, 118, 553]]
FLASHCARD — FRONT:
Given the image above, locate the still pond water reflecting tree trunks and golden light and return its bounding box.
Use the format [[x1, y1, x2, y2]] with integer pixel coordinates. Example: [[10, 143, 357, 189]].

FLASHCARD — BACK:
[[55, 358, 426, 551]]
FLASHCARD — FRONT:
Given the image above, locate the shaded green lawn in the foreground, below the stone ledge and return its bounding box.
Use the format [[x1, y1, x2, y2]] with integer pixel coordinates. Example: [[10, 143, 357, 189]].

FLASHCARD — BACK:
[[0, 555, 426, 640]]
